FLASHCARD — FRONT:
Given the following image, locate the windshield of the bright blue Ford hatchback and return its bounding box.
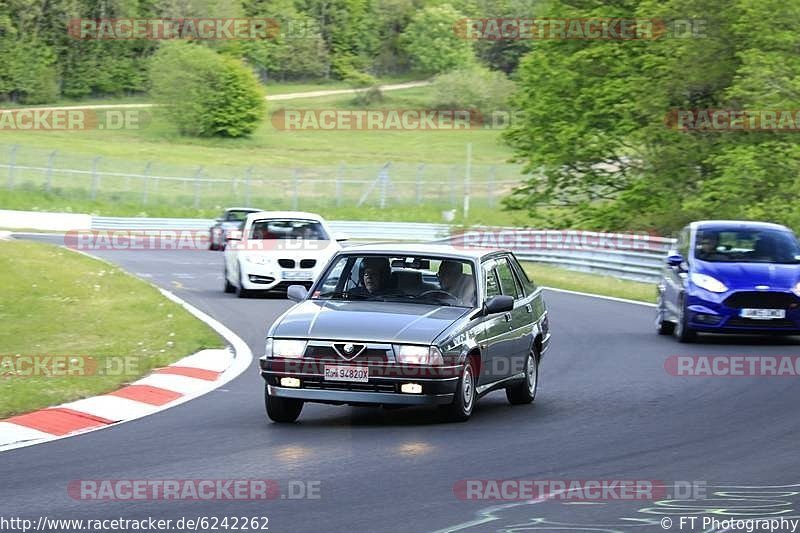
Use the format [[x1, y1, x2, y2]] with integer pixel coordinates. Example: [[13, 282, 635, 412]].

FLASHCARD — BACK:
[[694, 229, 800, 264]]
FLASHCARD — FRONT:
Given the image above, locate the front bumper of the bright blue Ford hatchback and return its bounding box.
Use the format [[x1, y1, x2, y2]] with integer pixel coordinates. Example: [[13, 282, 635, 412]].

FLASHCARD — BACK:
[[686, 289, 800, 335]]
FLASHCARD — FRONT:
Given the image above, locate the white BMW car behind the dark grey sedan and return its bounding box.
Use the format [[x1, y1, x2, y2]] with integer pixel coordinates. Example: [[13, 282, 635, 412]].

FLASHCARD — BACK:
[[225, 211, 346, 298]]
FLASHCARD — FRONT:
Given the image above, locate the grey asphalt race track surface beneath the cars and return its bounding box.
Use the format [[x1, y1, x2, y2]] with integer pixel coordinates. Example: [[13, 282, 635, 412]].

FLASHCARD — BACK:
[[0, 236, 800, 532]]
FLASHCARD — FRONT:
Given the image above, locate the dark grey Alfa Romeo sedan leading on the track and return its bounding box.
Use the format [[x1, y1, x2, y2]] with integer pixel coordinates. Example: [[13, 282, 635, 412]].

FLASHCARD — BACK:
[[260, 244, 550, 422]]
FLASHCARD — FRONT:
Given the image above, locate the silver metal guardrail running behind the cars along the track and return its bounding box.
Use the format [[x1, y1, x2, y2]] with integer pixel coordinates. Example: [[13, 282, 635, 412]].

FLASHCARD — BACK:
[[92, 217, 675, 283]]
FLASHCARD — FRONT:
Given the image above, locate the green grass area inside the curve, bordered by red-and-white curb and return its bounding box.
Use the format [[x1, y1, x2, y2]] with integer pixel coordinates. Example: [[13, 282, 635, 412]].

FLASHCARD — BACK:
[[0, 241, 223, 418]]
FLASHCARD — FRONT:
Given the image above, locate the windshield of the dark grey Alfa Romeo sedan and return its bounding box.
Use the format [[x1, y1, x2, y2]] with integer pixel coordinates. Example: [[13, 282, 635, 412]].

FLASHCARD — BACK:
[[311, 254, 477, 307]]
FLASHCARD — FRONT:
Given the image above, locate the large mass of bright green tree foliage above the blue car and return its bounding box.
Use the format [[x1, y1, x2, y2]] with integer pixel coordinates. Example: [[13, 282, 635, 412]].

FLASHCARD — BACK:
[[505, 0, 800, 234]]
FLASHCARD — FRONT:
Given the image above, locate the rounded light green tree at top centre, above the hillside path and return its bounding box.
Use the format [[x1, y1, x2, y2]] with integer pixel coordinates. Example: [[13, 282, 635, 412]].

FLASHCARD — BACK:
[[402, 4, 475, 74]]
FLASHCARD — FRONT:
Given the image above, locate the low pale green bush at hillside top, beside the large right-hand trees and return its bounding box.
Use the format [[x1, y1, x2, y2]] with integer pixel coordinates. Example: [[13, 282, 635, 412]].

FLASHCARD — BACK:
[[433, 65, 514, 116]]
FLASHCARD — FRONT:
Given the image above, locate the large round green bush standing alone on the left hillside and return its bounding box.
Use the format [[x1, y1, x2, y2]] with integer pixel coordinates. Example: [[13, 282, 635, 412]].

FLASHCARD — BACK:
[[150, 42, 266, 137]]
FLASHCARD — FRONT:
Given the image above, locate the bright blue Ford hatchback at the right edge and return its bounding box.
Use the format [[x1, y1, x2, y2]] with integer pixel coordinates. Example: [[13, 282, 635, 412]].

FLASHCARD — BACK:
[[656, 220, 800, 342]]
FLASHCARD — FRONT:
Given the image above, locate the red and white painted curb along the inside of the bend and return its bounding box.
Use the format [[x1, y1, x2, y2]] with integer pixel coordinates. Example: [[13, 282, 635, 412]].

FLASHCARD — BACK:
[[0, 289, 253, 451]]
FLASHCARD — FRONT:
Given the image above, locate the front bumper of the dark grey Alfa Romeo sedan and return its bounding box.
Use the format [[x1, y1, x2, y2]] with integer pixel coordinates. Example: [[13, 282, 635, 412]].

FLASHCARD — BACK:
[[259, 358, 461, 405]]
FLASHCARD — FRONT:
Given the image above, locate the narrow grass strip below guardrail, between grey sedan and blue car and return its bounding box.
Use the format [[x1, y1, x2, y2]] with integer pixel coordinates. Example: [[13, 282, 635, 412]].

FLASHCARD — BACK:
[[523, 262, 656, 303]]
